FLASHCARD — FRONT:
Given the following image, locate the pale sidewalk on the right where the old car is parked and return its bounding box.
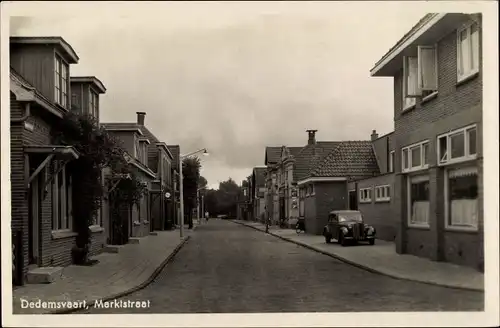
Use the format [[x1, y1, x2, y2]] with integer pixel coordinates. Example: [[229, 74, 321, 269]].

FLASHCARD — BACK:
[[233, 220, 484, 291]]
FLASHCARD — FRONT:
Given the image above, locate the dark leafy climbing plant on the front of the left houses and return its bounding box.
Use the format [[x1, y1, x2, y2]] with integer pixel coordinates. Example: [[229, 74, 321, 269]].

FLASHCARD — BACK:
[[52, 112, 146, 264]]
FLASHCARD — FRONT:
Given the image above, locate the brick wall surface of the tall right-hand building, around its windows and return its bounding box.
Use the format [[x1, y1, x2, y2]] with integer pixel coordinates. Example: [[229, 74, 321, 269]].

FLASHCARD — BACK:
[[394, 16, 483, 267]]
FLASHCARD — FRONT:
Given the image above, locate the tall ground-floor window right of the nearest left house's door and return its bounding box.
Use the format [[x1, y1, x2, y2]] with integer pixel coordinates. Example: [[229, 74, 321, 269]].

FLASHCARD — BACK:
[[52, 167, 73, 231]]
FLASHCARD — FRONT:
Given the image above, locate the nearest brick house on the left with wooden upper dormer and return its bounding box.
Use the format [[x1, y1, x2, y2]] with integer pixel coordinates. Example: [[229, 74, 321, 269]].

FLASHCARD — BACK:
[[10, 37, 97, 284]]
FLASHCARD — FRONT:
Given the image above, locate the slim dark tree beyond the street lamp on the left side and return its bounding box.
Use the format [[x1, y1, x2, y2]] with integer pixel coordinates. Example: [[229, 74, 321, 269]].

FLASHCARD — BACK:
[[182, 157, 200, 229]]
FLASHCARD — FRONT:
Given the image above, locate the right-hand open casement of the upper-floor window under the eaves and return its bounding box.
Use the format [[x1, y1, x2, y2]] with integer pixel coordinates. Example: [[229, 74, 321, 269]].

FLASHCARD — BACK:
[[418, 46, 437, 91]]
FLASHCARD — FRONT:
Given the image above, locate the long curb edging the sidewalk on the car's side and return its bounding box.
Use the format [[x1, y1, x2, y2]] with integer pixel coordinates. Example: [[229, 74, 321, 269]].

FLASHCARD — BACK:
[[231, 220, 484, 293]]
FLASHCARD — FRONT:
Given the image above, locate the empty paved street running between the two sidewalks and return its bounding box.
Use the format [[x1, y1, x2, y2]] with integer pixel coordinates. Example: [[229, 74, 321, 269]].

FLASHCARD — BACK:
[[80, 219, 484, 314]]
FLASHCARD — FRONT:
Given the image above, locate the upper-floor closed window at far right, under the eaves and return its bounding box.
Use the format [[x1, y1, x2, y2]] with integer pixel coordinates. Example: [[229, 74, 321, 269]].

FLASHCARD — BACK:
[[457, 22, 479, 82]]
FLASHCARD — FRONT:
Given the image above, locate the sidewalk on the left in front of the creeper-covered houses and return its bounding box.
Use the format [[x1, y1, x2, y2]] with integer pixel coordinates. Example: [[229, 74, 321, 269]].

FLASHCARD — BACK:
[[12, 222, 197, 314]]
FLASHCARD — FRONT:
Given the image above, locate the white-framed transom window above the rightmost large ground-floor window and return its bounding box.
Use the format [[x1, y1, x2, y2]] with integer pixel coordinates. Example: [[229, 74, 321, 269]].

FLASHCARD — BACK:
[[437, 125, 477, 165]]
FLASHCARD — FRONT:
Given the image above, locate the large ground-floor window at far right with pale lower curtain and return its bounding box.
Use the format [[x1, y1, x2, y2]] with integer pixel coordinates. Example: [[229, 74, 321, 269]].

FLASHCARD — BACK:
[[445, 167, 479, 230]]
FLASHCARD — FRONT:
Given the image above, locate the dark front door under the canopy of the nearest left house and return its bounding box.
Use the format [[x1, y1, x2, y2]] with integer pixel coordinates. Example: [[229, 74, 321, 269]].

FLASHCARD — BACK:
[[28, 174, 42, 264]]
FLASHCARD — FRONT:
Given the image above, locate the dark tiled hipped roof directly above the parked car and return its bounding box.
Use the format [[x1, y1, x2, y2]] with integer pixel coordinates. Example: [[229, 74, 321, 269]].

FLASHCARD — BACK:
[[307, 141, 380, 180]]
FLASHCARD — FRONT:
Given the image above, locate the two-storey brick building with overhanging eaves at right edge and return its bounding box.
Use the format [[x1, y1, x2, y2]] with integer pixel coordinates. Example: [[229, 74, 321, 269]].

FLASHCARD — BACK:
[[371, 13, 484, 270]]
